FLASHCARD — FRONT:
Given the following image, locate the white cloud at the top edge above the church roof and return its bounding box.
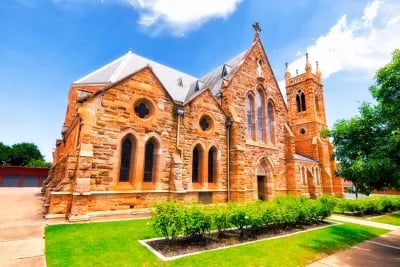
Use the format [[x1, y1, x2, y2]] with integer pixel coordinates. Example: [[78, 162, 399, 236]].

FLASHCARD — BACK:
[[123, 0, 242, 35]]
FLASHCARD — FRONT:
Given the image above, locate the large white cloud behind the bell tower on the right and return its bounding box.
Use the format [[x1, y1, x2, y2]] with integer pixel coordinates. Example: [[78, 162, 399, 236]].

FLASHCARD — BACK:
[[279, 0, 400, 94]]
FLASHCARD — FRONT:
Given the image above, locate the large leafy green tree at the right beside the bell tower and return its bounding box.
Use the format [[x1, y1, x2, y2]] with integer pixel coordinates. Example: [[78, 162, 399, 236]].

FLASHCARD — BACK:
[[325, 49, 400, 194]]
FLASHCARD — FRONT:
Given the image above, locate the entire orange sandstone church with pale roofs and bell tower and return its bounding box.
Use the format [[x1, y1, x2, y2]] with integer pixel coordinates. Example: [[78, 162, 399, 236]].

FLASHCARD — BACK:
[[45, 23, 343, 220]]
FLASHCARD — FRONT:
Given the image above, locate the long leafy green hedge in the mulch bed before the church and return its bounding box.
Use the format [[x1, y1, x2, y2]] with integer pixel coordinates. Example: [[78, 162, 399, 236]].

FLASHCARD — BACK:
[[151, 195, 335, 239]]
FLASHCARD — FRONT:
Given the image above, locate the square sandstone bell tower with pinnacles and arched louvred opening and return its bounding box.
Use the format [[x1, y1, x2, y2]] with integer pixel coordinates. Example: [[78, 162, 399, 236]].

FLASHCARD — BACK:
[[285, 54, 343, 196]]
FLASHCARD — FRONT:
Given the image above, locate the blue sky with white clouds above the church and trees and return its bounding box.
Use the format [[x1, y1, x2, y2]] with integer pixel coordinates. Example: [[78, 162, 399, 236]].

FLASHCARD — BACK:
[[0, 0, 400, 161]]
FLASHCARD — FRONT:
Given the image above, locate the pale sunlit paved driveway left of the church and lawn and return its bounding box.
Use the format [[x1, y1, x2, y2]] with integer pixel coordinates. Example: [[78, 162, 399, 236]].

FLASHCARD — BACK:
[[0, 187, 46, 267]]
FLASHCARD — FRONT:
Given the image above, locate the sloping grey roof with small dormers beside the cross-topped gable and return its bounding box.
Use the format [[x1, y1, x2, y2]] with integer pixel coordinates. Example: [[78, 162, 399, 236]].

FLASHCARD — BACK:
[[185, 50, 248, 102]]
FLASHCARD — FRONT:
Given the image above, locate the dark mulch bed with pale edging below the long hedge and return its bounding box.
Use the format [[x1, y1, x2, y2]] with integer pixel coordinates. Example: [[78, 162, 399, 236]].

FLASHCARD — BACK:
[[146, 222, 331, 257]]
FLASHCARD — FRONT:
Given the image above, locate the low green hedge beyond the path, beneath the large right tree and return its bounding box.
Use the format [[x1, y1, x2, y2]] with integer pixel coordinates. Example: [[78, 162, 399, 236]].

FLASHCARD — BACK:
[[335, 196, 400, 216]]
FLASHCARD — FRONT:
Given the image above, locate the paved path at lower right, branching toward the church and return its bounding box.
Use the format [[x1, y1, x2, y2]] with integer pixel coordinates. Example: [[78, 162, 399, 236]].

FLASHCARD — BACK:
[[308, 215, 400, 267]]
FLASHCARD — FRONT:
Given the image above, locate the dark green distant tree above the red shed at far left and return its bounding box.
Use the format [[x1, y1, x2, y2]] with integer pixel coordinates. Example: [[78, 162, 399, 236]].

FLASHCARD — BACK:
[[0, 142, 51, 167]]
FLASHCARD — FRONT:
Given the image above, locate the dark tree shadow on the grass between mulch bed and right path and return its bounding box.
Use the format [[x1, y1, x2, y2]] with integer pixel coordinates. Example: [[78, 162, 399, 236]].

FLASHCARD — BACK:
[[302, 225, 384, 254]]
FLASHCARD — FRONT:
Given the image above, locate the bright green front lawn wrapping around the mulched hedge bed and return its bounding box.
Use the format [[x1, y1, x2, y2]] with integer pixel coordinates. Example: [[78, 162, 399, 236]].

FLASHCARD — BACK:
[[45, 220, 388, 267]]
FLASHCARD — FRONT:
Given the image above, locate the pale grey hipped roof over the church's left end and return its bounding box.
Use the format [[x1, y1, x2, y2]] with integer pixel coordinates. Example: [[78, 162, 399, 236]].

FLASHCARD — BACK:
[[74, 51, 198, 102]]
